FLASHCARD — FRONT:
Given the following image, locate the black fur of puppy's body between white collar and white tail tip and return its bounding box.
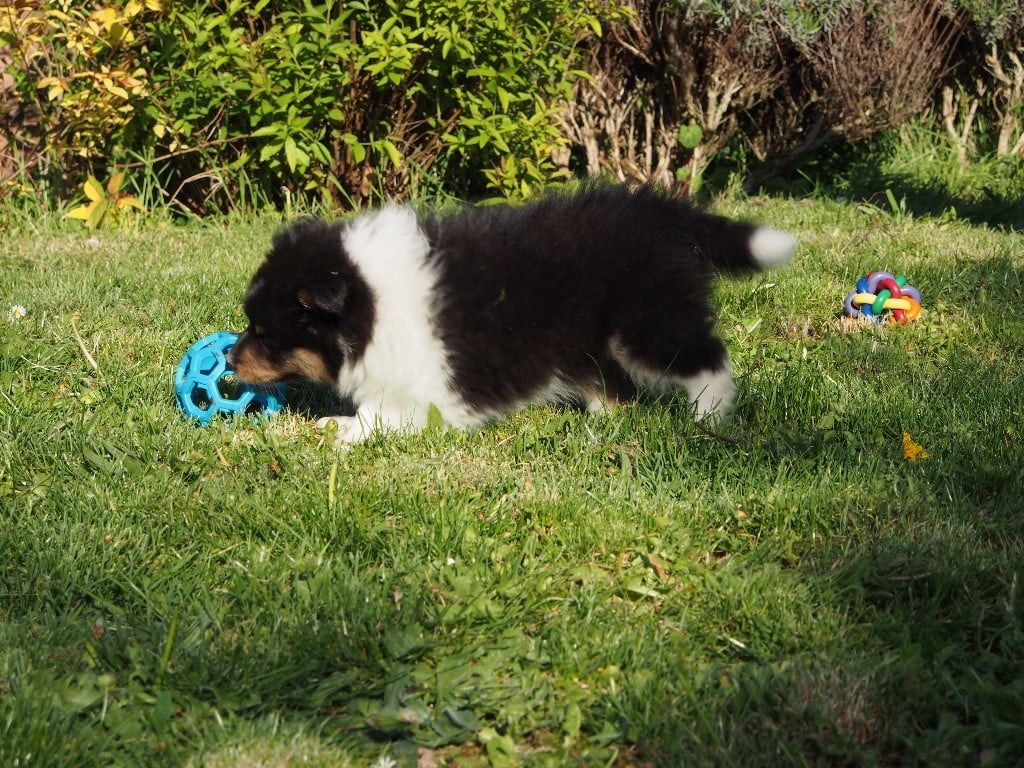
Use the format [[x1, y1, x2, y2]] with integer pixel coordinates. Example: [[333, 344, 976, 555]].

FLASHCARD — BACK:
[[425, 186, 757, 410]]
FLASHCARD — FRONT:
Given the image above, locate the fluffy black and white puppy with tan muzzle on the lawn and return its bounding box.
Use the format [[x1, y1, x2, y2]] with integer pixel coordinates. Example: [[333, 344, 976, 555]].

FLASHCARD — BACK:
[[230, 185, 797, 442]]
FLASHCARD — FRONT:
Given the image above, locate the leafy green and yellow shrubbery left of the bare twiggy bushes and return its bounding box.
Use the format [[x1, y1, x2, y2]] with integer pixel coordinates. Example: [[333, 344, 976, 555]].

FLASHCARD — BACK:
[[4, 0, 599, 212]]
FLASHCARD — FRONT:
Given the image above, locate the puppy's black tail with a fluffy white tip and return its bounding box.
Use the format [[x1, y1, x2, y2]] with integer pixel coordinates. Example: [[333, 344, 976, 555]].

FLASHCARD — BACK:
[[696, 208, 798, 272]]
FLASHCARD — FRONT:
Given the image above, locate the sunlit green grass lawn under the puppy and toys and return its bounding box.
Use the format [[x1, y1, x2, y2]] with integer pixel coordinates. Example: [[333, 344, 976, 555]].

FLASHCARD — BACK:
[[0, 193, 1024, 767]]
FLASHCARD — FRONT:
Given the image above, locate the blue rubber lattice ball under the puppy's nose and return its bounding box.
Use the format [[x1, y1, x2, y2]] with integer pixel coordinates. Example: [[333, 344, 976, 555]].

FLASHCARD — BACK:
[[174, 331, 285, 427]]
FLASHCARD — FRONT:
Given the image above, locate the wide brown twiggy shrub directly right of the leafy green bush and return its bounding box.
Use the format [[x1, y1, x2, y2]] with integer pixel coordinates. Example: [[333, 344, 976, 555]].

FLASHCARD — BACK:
[[563, 0, 958, 191]]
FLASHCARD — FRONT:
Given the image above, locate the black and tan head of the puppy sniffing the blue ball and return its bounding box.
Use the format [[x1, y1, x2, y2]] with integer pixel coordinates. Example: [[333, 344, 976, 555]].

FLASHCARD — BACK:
[[230, 220, 374, 384]]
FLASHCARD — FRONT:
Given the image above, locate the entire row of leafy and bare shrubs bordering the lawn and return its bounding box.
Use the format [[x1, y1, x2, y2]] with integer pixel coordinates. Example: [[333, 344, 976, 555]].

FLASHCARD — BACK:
[[0, 0, 1024, 214]]
